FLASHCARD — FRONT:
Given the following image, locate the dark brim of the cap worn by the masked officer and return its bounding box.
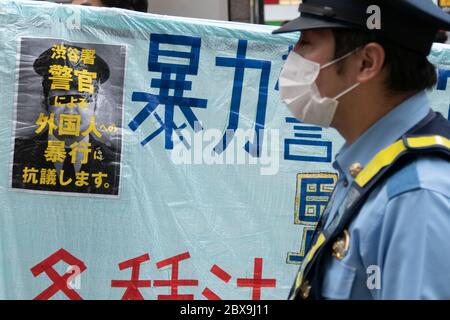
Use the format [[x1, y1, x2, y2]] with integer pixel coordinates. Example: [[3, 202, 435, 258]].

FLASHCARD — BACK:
[[272, 14, 355, 34]]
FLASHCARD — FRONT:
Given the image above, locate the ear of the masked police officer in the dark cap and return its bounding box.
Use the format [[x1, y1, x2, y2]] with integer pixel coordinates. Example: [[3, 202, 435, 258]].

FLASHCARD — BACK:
[[357, 42, 386, 83]]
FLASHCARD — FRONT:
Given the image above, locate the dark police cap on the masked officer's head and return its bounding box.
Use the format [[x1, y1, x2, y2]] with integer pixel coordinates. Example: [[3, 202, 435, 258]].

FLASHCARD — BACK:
[[273, 0, 450, 55]]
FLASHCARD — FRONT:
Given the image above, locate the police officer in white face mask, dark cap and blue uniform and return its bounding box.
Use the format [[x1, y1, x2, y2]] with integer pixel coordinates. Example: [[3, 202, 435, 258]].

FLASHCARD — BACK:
[[274, 0, 450, 299]]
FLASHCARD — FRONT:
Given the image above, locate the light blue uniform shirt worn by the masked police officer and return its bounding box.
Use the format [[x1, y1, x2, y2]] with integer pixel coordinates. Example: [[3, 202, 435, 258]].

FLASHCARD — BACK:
[[322, 92, 450, 299]]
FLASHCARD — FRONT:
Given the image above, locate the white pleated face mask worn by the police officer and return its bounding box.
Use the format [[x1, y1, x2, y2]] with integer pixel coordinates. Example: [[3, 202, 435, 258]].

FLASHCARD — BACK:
[[279, 50, 360, 128]]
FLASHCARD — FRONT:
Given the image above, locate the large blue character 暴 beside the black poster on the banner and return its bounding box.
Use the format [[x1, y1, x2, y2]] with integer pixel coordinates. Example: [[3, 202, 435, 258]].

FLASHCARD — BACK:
[[128, 34, 208, 150]]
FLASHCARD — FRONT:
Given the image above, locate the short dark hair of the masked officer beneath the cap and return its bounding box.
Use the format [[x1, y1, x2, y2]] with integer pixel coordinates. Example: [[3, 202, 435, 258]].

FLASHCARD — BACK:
[[332, 29, 437, 93]]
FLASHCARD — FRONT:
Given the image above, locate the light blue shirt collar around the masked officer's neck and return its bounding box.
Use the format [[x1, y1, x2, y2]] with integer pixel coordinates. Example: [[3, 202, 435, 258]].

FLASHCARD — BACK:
[[333, 91, 430, 182]]
